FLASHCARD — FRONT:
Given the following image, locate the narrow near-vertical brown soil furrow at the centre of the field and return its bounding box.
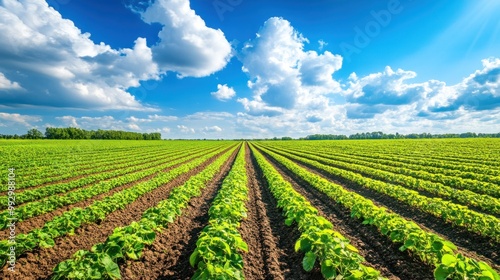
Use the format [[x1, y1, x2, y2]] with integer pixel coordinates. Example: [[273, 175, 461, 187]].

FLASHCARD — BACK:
[[240, 145, 284, 280]]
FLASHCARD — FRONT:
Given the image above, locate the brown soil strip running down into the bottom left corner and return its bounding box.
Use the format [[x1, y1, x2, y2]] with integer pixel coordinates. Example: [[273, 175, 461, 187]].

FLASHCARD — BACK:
[[0, 145, 235, 280]]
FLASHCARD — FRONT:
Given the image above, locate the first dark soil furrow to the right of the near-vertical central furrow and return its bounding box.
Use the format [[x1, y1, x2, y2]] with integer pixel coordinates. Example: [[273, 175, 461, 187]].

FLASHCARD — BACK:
[[261, 148, 434, 280]]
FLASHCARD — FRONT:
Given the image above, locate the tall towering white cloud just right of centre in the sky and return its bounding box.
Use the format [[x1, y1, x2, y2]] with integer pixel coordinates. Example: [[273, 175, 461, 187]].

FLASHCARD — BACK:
[[238, 17, 342, 115]]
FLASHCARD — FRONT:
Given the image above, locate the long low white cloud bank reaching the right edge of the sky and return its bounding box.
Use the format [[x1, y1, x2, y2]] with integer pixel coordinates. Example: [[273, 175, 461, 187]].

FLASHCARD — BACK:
[[343, 58, 500, 120]]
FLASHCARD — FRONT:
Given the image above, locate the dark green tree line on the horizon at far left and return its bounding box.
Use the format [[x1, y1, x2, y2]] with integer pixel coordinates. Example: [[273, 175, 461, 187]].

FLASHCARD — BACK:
[[0, 127, 161, 140]]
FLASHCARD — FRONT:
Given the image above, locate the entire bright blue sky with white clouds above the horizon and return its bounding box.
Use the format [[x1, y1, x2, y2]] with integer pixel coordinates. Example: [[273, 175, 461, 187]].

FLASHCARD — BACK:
[[0, 0, 500, 138]]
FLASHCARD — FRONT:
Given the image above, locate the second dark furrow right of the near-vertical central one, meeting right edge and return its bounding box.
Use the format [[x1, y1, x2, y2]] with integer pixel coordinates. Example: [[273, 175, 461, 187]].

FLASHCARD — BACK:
[[274, 150, 500, 271]]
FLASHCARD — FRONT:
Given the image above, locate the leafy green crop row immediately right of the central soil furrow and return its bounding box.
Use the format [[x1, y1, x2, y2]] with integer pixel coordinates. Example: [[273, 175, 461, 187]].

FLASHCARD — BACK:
[[252, 144, 383, 279]]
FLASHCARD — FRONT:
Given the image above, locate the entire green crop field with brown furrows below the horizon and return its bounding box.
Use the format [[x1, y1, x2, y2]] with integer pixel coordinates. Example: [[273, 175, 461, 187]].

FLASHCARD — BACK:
[[0, 138, 500, 280]]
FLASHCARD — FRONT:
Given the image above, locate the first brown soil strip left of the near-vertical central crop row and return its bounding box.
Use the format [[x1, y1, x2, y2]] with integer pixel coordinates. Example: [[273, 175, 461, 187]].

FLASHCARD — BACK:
[[120, 145, 238, 279]]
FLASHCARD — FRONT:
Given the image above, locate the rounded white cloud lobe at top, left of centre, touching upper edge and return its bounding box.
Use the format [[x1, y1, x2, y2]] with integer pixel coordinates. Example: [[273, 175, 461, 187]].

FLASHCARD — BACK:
[[135, 0, 232, 77]]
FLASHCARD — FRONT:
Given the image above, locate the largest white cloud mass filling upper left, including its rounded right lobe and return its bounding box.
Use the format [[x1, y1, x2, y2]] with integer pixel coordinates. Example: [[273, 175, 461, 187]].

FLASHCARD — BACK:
[[0, 0, 232, 111]]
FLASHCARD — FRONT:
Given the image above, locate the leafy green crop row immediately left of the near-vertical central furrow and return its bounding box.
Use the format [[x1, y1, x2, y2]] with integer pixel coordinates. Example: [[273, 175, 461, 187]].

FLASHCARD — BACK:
[[189, 147, 248, 280]]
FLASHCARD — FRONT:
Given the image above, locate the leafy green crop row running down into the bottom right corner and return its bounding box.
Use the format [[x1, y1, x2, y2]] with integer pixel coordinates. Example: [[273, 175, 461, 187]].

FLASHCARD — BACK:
[[254, 144, 500, 280]]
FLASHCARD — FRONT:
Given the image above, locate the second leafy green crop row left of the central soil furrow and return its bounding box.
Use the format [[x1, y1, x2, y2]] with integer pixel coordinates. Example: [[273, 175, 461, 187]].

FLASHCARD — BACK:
[[53, 144, 239, 279]]
